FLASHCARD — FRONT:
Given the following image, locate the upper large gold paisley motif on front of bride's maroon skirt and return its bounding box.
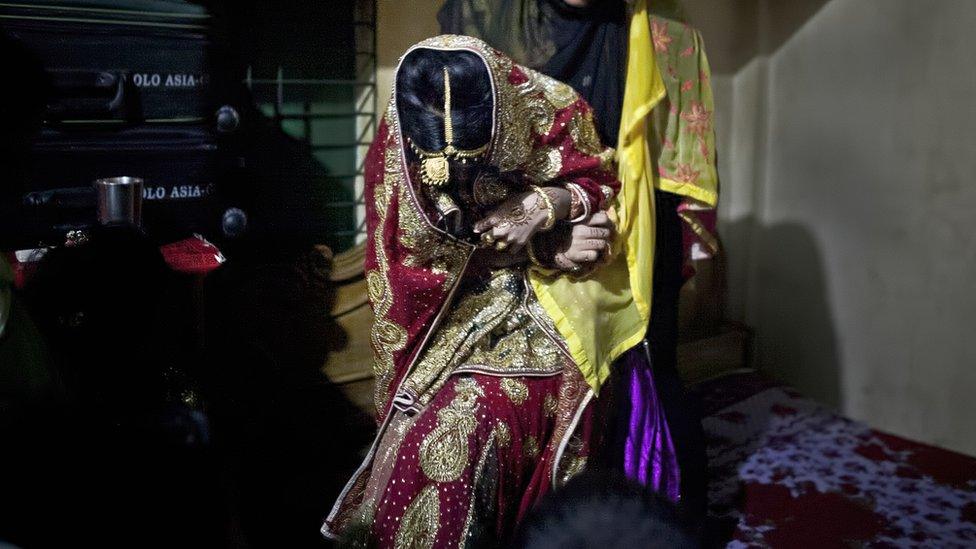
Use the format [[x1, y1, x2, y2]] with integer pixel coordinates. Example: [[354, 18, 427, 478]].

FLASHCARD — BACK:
[[420, 378, 485, 482]]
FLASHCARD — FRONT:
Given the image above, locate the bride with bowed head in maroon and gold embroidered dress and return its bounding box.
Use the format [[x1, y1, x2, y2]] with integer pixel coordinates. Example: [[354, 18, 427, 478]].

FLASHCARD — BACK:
[[323, 35, 632, 547]]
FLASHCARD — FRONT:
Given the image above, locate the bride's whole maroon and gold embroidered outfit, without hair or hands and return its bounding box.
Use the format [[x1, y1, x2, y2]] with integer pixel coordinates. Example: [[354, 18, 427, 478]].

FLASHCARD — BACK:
[[322, 35, 618, 547]]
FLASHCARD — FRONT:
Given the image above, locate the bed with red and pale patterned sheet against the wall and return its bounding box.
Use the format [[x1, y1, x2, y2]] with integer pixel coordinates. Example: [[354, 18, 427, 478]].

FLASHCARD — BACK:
[[695, 373, 976, 548]]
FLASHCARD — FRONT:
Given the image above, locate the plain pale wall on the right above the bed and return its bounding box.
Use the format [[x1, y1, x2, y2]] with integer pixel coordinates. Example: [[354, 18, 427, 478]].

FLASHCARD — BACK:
[[705, 0, 976, 454]]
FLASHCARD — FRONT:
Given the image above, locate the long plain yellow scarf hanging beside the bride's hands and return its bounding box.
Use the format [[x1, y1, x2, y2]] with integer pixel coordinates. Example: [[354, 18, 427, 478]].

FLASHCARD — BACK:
[[531, 0, 666, 391]]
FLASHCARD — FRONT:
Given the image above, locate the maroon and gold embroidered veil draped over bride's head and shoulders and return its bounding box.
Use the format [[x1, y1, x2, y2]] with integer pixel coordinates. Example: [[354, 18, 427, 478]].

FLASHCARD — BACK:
[[365, 35, 619, 421]]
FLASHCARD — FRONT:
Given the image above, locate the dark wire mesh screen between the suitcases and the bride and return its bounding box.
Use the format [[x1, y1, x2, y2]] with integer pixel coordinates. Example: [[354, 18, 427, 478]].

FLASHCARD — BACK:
[[245, 0, 377, 252]]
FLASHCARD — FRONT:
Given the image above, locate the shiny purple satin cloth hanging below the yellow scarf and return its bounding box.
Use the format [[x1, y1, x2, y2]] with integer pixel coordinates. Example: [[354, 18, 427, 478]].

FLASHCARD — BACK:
[[611, 344, 681, 502]]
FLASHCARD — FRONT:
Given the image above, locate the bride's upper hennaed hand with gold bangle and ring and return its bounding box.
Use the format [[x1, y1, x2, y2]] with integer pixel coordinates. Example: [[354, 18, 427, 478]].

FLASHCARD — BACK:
[[474, 187, 570, 254]]
